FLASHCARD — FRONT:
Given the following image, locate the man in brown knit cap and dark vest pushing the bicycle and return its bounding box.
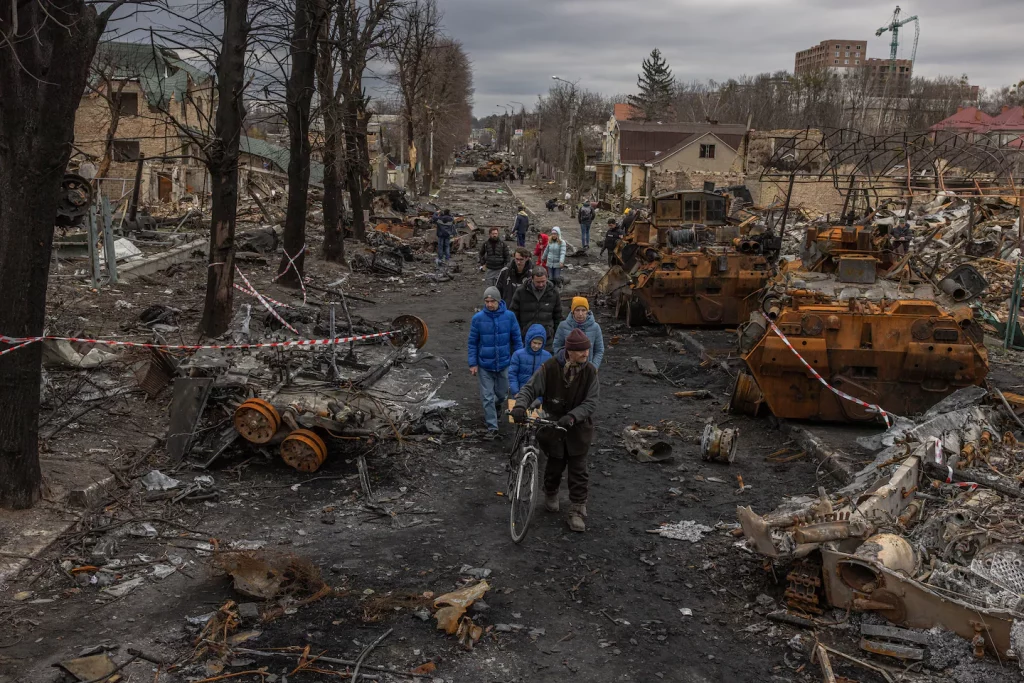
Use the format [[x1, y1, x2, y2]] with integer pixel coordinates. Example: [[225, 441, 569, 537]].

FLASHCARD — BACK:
[[512, 329, 598, 531]]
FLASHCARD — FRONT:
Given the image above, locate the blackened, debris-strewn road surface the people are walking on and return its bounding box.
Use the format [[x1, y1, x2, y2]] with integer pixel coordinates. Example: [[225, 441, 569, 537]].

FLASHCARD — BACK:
[[0, 169, 888, 683]]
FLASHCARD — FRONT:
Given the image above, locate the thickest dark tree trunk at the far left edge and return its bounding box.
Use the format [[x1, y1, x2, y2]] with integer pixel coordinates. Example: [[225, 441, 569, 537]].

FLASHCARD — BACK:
[[0, 0, 103, 509]]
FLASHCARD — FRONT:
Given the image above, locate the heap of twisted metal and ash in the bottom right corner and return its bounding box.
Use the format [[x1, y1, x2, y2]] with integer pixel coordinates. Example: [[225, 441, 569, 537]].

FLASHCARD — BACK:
[[737, 387, 1024, 680]]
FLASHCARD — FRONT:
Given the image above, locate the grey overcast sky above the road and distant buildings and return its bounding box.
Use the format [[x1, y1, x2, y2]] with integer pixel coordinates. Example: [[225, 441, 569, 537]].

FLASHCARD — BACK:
[[446, 0, 1024, 117]]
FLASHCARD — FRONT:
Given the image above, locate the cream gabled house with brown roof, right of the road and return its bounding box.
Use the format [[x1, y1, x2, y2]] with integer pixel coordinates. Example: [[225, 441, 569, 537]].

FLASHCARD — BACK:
[[597, 115, 748, 199]]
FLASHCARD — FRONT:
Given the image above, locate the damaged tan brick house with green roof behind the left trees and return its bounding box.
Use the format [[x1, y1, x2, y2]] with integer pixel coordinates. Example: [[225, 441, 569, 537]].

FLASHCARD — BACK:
[[71, 41, 324, 205]]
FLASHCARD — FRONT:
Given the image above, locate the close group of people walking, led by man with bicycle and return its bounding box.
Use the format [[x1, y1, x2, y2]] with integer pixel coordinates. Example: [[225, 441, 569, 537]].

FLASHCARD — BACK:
[[467, 233, 604, 531]]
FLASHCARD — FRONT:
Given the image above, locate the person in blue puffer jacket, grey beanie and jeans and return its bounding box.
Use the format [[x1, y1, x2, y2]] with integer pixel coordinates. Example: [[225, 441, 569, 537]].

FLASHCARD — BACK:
[[467, 287, 522, 439]]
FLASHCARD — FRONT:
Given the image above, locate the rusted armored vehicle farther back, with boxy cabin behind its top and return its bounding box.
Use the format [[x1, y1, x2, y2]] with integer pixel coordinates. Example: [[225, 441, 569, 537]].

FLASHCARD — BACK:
[[599, 190, 779, 327]]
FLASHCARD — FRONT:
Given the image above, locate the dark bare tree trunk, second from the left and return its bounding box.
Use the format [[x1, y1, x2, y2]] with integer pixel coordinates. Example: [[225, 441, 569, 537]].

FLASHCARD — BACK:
[[200, 0, 249, 337]]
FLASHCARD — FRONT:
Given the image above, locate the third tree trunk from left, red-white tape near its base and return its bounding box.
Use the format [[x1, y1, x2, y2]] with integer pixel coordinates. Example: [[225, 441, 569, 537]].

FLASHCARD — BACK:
[[278, 0, 324, 287]]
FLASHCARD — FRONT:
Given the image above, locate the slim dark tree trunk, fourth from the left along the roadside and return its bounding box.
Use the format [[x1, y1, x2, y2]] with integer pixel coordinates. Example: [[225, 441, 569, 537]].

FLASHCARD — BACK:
[[316, 30, 345, 263]]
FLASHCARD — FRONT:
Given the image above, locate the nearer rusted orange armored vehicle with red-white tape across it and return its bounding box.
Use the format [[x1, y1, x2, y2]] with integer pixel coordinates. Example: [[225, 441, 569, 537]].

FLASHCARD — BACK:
[[731, 127, 988, 422]]
